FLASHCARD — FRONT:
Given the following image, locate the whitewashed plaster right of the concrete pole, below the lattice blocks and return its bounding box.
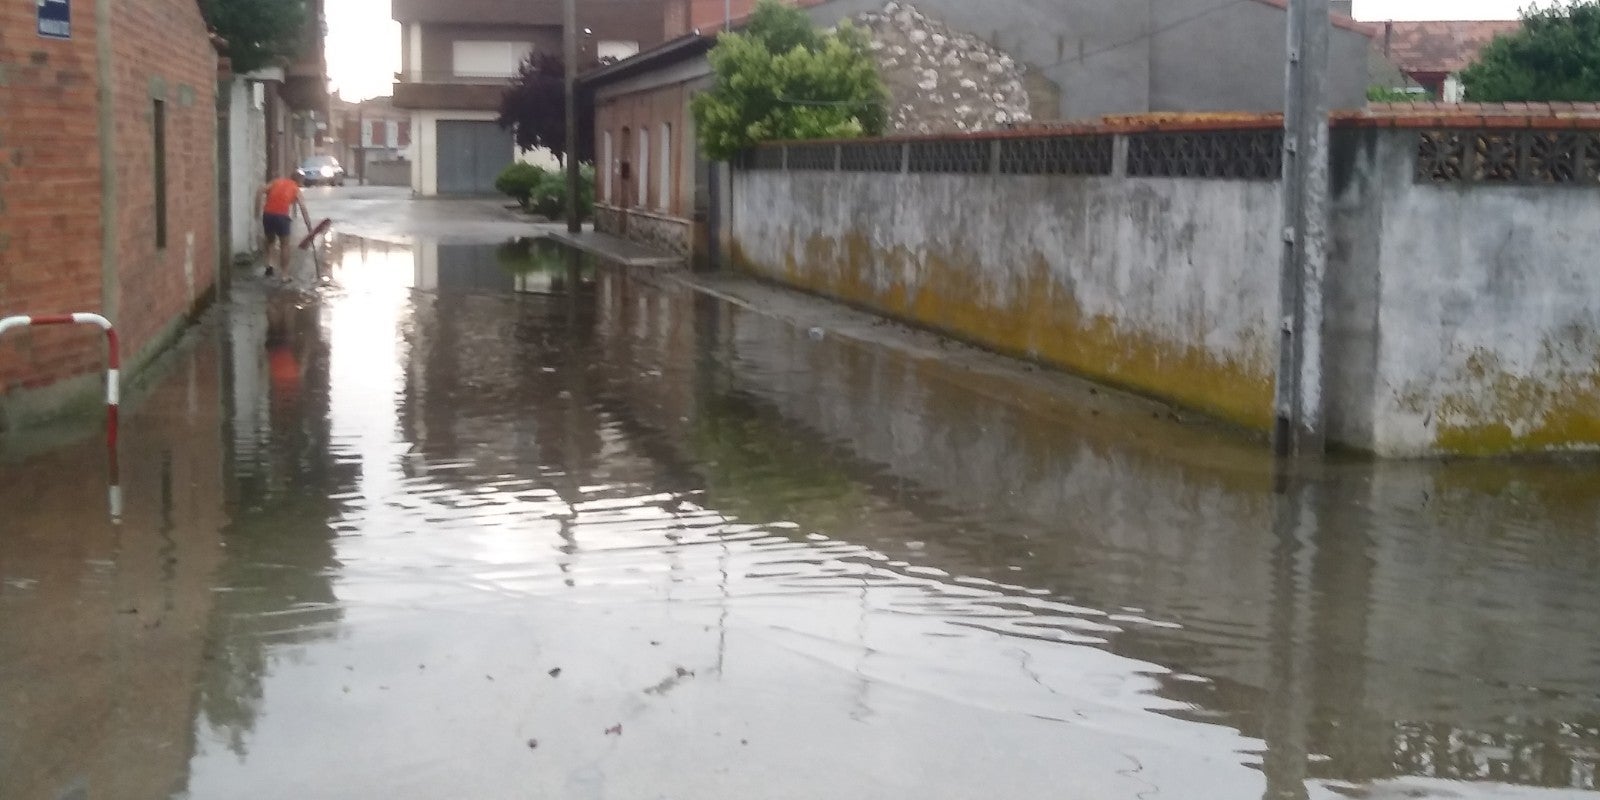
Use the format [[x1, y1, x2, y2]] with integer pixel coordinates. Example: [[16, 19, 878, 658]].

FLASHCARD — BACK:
[[1373, 150, 1600, 456]]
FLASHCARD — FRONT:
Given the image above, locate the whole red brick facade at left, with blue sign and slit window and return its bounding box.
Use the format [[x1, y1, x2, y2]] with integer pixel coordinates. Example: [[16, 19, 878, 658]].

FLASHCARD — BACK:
[[0, 0, 218, 427]]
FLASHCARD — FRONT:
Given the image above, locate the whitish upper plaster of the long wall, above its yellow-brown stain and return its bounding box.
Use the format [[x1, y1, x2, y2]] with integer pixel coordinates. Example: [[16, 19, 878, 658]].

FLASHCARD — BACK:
[[731, 171, 1282, 419]]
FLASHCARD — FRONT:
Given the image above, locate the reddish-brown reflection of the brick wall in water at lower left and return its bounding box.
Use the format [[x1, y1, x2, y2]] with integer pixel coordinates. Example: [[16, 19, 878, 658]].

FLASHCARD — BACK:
[[0, 329, 226, 798]]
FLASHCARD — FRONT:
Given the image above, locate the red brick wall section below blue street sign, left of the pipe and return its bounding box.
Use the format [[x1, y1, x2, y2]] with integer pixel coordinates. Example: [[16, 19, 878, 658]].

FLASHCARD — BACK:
[[0, 2, 102, 395]]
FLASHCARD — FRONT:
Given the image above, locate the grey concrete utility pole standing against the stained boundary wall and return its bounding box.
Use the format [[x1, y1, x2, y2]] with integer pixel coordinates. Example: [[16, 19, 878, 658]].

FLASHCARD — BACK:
[[1274, 0, 1331, 458]]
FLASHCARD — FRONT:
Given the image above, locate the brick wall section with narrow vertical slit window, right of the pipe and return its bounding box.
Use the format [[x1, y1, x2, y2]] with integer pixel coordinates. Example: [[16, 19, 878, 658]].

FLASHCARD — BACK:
[[112, 0, 218, 363]]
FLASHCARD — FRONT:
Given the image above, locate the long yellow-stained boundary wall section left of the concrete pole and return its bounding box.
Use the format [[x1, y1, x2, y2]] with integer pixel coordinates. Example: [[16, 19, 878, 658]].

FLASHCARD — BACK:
[[733, 128, 1280, 430]]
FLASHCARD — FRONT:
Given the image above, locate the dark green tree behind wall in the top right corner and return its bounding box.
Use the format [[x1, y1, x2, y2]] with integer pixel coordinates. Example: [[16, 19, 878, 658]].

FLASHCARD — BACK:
[[1461, 0, 1600, 102]]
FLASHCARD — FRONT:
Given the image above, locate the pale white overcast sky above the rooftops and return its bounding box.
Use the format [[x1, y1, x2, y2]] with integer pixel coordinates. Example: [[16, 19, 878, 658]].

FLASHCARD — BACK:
[[326, 0, 1526, 99]]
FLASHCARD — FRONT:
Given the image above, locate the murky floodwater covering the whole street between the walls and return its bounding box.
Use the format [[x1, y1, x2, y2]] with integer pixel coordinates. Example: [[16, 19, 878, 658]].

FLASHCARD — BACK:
[[0, 225, 1600, 800]]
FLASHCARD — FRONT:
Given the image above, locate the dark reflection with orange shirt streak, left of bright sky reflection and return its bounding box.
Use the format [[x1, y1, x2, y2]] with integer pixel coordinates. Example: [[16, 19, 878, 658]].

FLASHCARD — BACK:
[[198, 285, 355, 757]]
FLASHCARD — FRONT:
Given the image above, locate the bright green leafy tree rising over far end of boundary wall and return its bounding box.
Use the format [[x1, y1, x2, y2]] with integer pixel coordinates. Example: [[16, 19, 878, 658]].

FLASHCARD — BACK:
[[693, 0, 888, 160]]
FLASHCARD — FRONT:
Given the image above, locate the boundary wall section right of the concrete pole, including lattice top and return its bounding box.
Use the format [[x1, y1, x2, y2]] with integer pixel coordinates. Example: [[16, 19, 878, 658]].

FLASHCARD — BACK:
[[1325, 130, 1600, 456]]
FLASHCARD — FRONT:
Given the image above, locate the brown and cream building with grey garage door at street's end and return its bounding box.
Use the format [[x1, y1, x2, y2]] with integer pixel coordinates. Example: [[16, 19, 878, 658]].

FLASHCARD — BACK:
[[392, 0, 666, 195]]
